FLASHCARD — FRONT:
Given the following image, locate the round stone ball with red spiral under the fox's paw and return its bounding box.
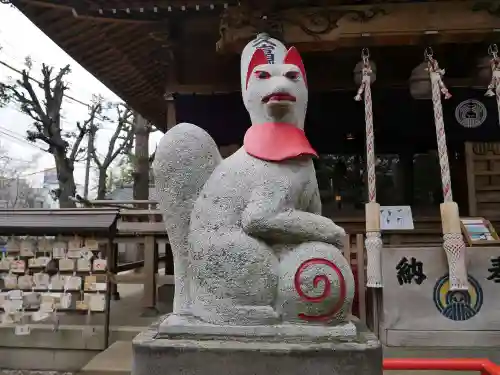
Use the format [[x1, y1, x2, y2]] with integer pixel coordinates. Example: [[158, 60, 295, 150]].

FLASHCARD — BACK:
[[276, 242, 355, 324]]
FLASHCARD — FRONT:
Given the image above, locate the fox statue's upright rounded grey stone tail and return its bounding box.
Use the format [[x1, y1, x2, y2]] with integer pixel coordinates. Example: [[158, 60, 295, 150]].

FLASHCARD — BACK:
[[153, 123, 222, 315]]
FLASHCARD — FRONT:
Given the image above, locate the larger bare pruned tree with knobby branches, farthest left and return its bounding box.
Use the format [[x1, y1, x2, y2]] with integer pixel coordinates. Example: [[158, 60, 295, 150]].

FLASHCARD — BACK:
[[0, 62, 102, 208]]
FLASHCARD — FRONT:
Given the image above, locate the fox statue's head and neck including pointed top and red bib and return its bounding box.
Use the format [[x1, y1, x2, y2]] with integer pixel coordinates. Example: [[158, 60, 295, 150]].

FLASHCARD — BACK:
[[241, 34, 317, 162]]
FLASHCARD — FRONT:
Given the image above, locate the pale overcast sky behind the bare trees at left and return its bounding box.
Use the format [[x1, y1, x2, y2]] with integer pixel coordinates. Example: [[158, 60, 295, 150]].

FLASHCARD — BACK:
[[0, 4, 161, 195]]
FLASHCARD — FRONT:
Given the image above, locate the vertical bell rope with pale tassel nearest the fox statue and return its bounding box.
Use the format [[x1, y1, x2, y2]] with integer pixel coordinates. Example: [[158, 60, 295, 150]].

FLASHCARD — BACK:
[[354, 49, 383, 288]]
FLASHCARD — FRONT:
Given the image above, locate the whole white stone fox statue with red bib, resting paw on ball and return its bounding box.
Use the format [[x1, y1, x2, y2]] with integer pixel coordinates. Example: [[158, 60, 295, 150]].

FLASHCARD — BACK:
[[153, 39, 354, 325]]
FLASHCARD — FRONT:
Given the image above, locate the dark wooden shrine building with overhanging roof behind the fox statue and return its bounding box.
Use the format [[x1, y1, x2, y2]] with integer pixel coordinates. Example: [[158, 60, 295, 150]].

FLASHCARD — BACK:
[[12, 0, 500, 345]]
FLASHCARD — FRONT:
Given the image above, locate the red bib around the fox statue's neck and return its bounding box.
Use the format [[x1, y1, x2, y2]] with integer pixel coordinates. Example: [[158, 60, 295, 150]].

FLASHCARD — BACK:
[[243, 122, 318, 161]]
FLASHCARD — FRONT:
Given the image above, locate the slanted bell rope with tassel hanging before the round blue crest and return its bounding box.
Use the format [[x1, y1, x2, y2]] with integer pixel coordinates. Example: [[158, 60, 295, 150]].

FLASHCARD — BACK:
[[426, 51, 469, 290]]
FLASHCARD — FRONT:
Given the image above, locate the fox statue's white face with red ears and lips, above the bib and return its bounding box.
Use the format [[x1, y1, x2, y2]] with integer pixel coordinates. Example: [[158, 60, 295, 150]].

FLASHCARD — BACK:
[[242, 47, 308, 129]]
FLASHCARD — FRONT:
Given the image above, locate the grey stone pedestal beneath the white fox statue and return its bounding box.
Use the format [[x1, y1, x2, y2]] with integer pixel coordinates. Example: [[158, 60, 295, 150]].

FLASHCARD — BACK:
[[132, 323, 382, 375]]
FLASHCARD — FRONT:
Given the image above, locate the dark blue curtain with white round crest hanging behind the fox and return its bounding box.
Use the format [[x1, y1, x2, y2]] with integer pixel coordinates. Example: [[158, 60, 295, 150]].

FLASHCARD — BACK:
[[176, 88, 500, 153]]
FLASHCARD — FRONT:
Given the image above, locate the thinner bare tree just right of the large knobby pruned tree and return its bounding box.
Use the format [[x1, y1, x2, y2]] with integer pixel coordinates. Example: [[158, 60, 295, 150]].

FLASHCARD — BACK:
[[90, 104, 134, 199]]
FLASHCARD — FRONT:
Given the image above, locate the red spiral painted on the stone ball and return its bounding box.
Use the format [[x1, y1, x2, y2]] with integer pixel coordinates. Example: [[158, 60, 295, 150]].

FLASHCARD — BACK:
[[294, 258, 347, 321]]
